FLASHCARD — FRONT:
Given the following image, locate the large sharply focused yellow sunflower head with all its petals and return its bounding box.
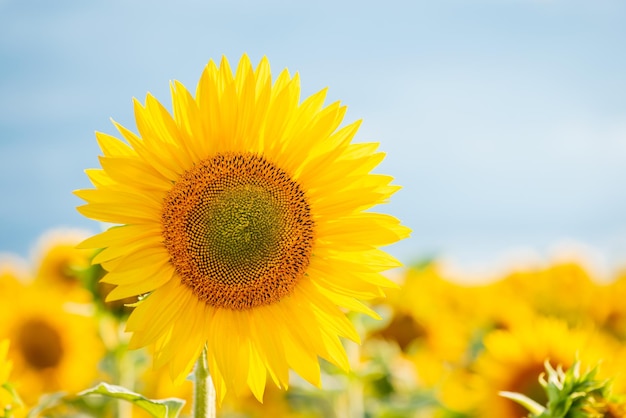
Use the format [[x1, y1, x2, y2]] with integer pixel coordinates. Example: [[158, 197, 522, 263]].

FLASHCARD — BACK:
[[76, 55, 409, 401]]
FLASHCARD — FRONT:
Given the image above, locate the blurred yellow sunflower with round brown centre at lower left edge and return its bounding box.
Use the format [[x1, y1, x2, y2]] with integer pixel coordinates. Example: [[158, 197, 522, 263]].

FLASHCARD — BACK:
[[0, 285, 103, 405]]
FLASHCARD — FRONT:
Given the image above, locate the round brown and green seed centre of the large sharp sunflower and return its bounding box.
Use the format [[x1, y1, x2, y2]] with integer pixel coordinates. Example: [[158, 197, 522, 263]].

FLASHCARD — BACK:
[[162, 153, 314, 310]]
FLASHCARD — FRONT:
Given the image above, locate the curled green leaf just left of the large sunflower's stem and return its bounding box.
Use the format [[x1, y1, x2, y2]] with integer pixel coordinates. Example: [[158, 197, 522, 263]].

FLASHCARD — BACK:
[[77, 382, 185, 418]]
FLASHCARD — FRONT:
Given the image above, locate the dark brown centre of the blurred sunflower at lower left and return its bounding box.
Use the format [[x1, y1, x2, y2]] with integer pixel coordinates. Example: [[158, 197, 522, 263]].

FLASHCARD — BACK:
[[17, 318, 63, 370]]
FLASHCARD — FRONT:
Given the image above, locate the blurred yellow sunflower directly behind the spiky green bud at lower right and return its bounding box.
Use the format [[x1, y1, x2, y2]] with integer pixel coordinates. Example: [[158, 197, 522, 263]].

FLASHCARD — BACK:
[[474, 317, 624, 418]]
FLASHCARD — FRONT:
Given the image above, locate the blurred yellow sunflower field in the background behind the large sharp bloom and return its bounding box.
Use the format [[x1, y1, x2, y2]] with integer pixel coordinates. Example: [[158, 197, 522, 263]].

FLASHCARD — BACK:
[[0, 230, 626, 418]]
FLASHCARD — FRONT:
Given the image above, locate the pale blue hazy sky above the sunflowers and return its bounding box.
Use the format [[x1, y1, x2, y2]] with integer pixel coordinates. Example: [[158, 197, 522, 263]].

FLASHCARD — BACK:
[[0, 0, 626, 272]]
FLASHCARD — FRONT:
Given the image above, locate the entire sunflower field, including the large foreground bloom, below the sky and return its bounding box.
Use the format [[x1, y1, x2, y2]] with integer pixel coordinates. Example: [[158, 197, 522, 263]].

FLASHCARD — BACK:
[[0, 55, 626, 418]]
